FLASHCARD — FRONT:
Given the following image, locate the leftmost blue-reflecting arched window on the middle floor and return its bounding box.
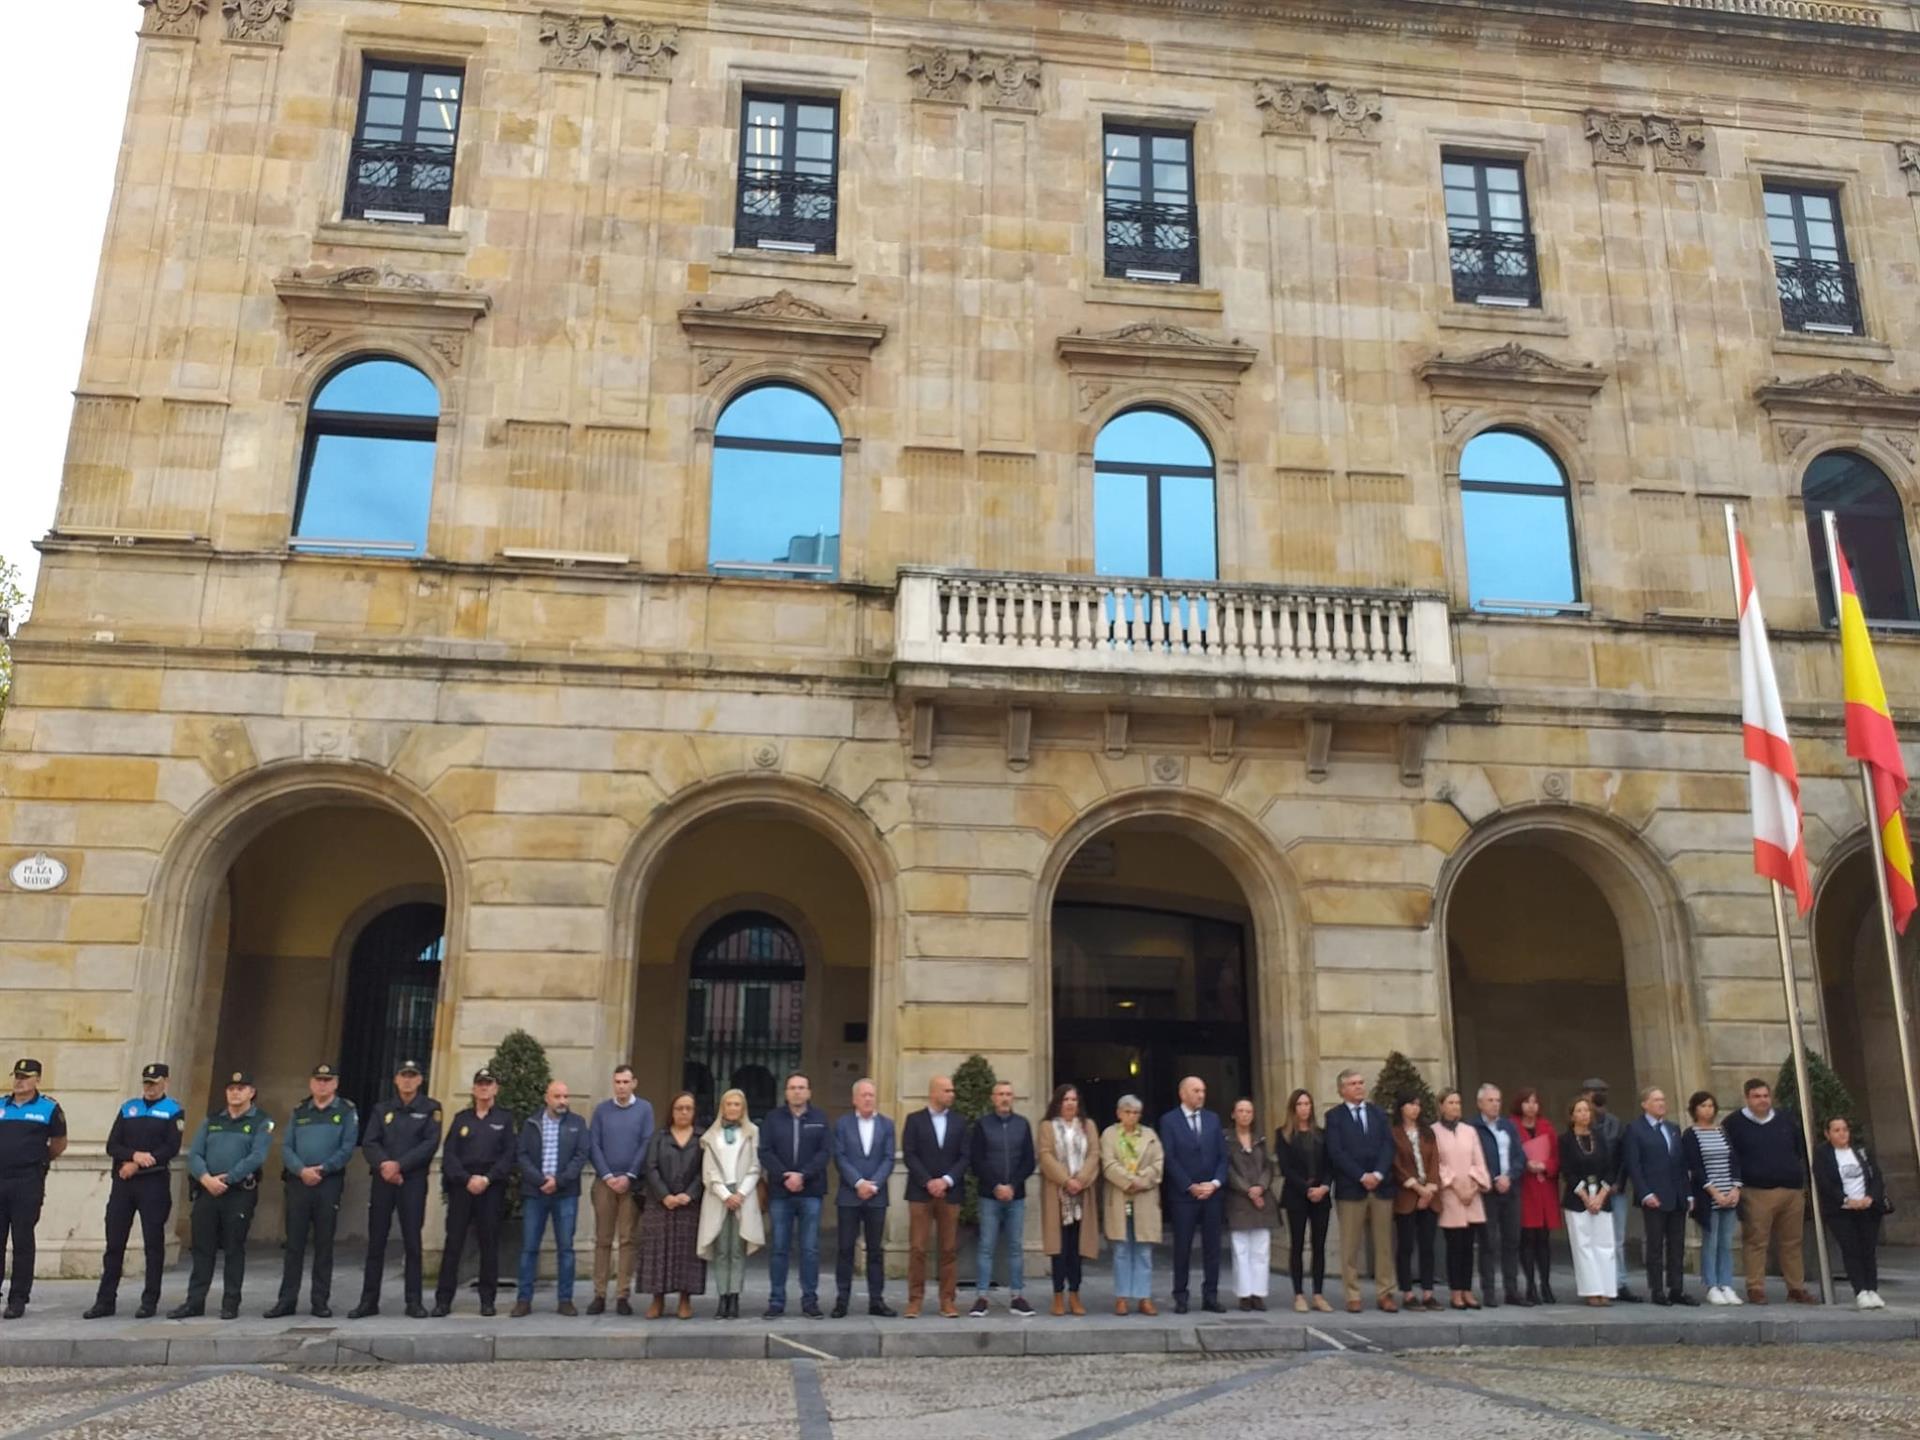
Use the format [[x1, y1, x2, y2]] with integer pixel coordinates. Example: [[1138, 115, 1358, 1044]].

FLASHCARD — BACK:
[[292, 359, 440, 555]]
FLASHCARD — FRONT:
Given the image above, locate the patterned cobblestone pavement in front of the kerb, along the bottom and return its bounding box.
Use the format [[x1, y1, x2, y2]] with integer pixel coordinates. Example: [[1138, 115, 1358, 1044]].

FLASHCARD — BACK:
[[0, 1342, 1920, 1440]]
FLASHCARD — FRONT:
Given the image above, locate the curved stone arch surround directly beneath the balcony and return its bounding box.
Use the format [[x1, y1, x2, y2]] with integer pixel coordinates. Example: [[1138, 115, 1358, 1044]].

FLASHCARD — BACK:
[[1029, 787, 1319, 1123]]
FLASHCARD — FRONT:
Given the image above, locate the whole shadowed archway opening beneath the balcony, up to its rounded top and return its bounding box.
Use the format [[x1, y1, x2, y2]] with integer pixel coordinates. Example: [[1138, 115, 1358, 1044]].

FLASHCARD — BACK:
[[1052, 820, 1258, 1125]]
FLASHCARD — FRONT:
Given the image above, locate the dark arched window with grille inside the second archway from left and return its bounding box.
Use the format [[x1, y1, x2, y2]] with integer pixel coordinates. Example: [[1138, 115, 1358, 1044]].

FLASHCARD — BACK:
[[680, 910, 806, 1119]]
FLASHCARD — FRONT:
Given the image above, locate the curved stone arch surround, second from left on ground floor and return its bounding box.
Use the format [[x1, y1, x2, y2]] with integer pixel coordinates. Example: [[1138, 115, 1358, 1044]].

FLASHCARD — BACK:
[[601, 774, 904, 1098]]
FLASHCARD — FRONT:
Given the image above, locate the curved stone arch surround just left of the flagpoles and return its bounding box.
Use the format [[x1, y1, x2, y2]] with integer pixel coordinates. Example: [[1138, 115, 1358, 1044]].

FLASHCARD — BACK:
[[1432, 804, 1707, 1125]]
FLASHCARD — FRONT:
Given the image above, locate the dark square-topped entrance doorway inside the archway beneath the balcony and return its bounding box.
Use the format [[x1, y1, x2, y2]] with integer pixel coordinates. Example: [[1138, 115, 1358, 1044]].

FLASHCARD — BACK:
[[1054, 900, 1254, 1129]]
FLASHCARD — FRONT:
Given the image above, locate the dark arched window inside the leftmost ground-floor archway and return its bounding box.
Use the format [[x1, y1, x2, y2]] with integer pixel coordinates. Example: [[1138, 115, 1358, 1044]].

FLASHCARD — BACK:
[[340, 902, 447, 1116]]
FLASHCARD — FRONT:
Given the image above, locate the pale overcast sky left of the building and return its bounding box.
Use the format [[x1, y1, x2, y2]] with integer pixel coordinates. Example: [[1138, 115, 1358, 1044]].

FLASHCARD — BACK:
[[0, 0, 140, 610]]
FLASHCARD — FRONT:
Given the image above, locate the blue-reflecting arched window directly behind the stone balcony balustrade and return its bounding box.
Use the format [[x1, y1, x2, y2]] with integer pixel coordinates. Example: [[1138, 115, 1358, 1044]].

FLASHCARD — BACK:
[[1092, 409, 1219, 580]]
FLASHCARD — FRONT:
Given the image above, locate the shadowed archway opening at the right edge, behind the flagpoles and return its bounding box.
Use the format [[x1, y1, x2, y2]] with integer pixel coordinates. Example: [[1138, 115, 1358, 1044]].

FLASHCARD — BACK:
[[1812, 847, 1920, 1242]]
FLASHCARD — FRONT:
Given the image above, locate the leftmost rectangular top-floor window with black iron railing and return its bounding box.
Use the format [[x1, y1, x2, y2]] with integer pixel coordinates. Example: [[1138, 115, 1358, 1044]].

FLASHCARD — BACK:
[[346, 60, 465, 225]]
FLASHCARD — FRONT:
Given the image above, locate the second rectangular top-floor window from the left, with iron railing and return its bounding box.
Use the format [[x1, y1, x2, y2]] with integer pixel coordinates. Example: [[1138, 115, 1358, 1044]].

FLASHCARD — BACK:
[[733, 92, 839, 255]]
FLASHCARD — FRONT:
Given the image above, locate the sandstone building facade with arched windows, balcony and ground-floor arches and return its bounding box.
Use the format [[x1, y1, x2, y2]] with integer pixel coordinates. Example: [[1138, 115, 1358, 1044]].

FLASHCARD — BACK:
[[0, 0, 1920, 1273]]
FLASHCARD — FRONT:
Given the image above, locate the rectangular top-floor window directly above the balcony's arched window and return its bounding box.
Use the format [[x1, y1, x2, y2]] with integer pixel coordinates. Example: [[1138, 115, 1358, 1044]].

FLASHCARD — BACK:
[[1102, 125, 1200, 284]]
